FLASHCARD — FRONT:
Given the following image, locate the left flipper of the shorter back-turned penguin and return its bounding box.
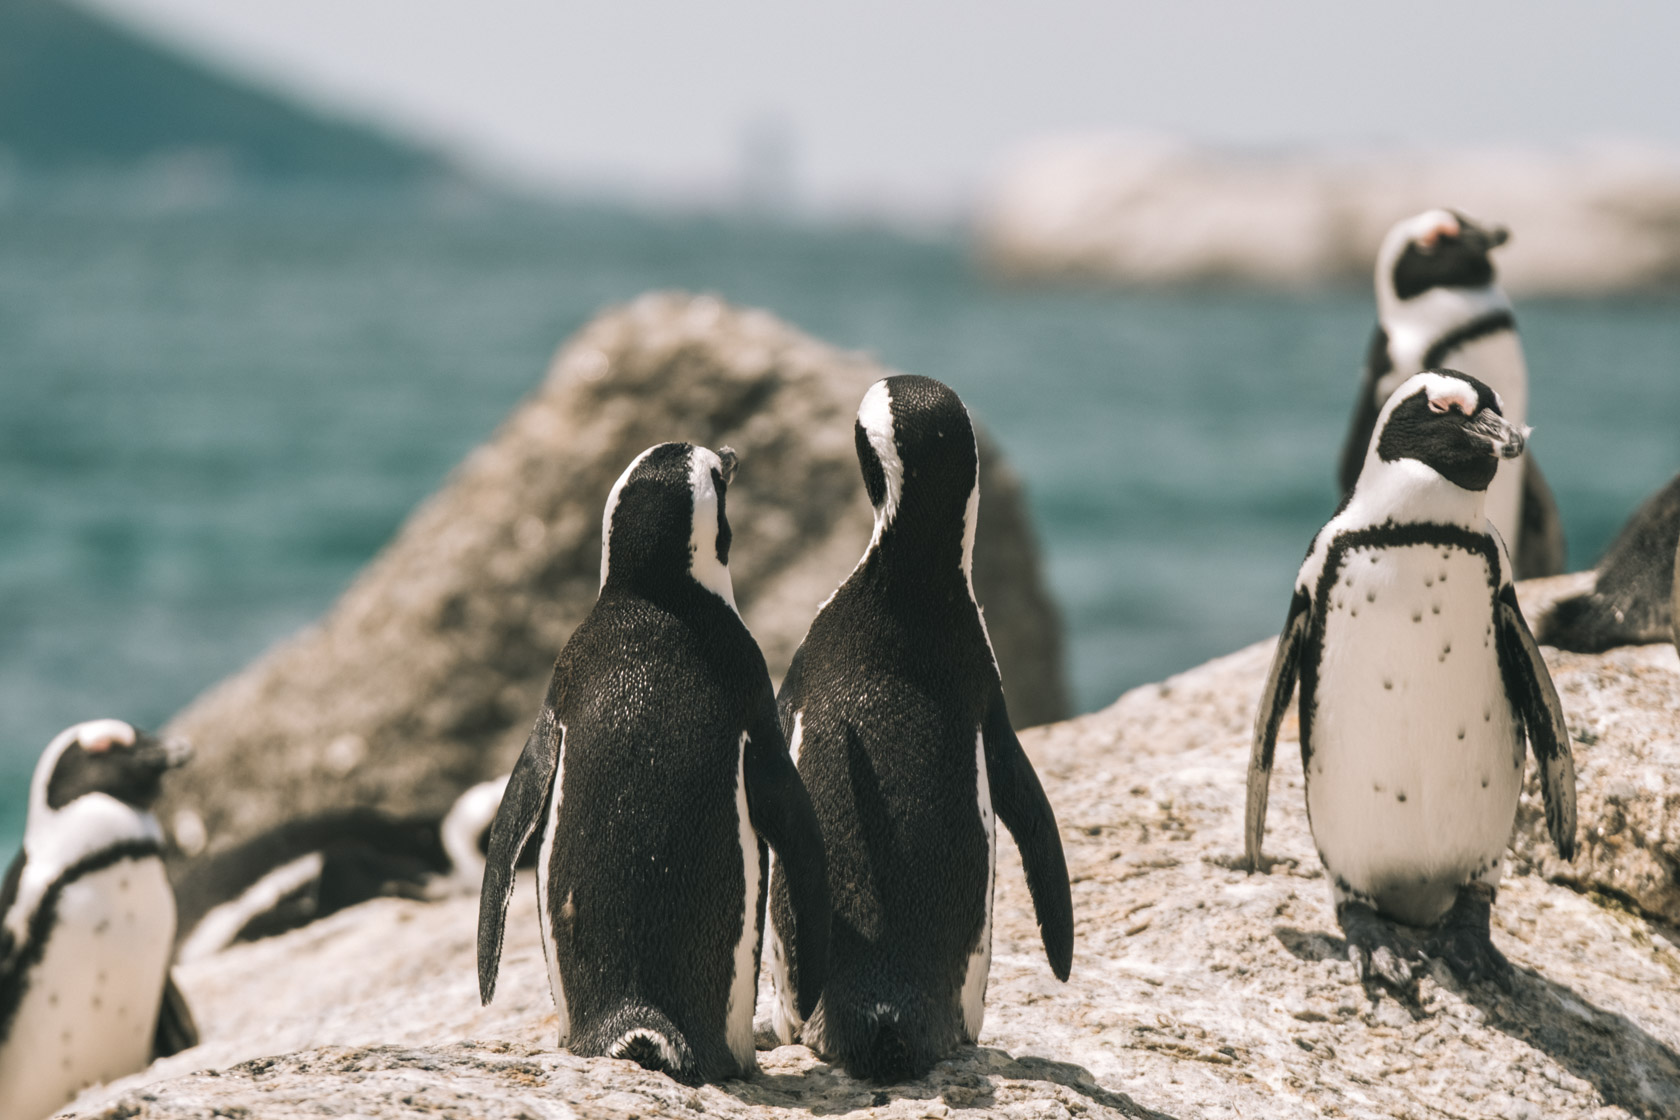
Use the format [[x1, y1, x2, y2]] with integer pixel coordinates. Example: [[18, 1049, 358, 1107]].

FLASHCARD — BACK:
[[479, 704, 566, 1004]]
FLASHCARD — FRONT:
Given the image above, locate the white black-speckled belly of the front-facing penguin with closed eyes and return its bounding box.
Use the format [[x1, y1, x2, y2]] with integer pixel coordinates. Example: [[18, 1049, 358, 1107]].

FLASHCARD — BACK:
[[1307, 546, 1524, 925]]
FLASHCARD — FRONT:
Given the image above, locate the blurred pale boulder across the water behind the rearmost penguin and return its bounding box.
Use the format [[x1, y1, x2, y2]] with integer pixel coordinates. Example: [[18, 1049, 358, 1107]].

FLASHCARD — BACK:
[[978, 136, 1680, 294]]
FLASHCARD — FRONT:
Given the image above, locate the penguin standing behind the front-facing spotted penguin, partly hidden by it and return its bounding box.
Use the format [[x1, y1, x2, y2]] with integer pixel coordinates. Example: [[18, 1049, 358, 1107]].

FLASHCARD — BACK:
[[1339, 210, 1564, 579]]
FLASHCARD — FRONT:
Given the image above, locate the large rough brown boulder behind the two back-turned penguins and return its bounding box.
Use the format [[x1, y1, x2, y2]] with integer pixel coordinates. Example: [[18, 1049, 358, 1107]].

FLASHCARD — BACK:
[[160, 294, 1067, 846]]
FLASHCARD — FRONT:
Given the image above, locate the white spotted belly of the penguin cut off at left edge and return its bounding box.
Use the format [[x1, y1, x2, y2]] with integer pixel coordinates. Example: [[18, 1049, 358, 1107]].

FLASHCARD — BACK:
[[0, 858, 175, 1120]]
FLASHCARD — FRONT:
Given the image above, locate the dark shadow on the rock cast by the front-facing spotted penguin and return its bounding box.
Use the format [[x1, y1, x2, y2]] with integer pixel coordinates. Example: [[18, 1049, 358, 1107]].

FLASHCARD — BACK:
[[1273, 927, 1680, 1120]]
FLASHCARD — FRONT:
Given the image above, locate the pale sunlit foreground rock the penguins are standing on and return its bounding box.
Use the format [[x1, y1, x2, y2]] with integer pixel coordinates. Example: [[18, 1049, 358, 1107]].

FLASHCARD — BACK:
[[74, 643, 1680, 1120]]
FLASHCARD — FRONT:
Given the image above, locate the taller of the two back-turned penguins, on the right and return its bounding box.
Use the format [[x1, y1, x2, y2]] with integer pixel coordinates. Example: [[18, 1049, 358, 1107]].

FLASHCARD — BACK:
[[769, 376, 1074, 1083]]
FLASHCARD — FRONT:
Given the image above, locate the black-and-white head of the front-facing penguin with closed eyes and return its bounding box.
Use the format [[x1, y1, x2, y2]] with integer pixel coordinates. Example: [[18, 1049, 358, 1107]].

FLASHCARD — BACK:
[[1376, 369, 1525, 490]]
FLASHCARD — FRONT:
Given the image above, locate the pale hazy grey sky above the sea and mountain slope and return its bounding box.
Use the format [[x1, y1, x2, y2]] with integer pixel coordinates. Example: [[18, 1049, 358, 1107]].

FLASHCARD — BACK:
[[82, 0, 1680, 207]]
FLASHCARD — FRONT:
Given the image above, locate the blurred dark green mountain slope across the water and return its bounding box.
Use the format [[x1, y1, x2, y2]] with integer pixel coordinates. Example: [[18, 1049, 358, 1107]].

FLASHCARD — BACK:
[[0, 0, 449, 181]]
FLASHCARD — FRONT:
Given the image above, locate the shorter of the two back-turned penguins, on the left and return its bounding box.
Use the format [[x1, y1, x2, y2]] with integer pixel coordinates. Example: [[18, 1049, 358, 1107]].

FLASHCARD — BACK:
[[479, 443, 830, 1085]]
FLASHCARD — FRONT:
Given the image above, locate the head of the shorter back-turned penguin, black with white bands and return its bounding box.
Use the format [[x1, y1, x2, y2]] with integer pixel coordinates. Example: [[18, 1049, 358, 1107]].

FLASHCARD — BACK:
[[601, 443, 736, 606]]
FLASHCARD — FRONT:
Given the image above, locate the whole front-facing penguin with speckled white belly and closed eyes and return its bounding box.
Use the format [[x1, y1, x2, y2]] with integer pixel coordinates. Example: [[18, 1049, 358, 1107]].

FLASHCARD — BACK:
[[1245, 369, 1576, 989]]
